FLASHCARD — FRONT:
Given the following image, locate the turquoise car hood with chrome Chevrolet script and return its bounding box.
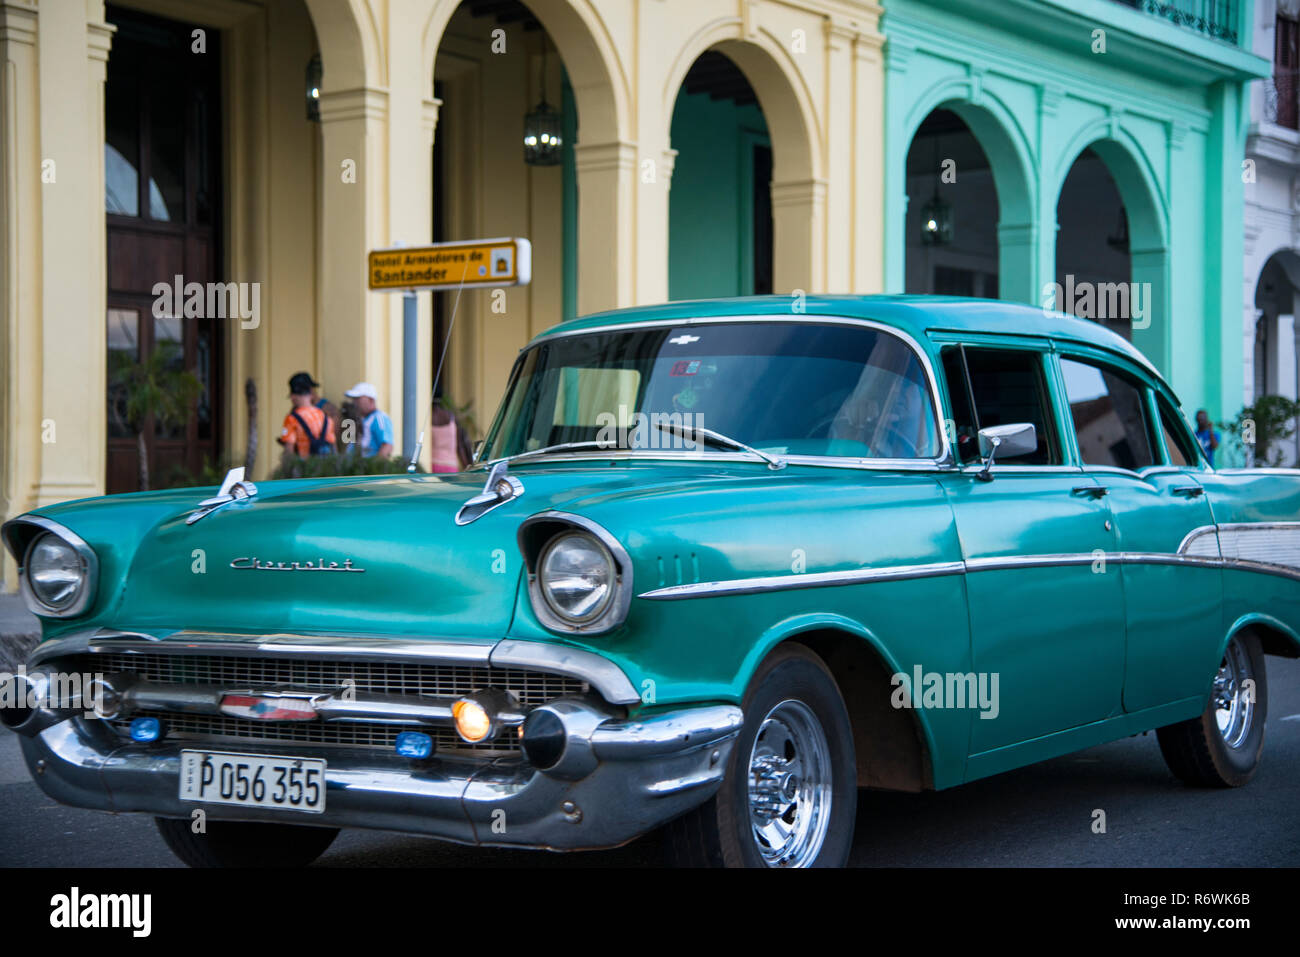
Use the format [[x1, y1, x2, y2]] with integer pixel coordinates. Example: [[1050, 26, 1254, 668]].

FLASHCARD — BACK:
[[27, 460, 873, 638]]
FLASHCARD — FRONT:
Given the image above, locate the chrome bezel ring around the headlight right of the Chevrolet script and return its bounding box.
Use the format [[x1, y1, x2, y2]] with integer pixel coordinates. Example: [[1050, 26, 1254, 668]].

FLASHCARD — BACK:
[[519, 511, 632, 635]]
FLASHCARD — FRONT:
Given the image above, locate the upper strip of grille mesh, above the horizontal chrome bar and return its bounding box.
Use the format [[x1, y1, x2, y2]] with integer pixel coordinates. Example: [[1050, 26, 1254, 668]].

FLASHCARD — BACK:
[[67, 651, 588, 710]]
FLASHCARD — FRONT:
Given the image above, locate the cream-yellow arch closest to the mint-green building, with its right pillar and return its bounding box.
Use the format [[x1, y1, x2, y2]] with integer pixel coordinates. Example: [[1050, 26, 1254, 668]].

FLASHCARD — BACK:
[[660, 17, 826, 294]]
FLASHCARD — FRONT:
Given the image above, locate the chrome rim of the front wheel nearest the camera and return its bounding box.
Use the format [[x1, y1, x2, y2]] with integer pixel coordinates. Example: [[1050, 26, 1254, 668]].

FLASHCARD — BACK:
[[749, 700, 832, 867]]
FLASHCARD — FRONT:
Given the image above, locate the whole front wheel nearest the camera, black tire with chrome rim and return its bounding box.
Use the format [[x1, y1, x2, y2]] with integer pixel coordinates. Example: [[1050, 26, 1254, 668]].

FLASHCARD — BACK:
[[666, 645, 858, 867]]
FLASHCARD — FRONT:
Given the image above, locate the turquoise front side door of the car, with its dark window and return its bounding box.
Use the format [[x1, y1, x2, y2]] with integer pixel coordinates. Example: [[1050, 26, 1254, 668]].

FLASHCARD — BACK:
[[941, 337, 1123, 772]]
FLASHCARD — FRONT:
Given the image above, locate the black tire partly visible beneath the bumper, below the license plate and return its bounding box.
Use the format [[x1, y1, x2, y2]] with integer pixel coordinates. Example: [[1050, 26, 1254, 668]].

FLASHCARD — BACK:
[[153, 818, 338, 867]]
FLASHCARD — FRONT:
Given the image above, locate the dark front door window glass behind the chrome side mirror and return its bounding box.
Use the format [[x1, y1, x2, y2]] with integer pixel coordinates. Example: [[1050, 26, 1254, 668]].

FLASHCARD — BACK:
[[943, 346, 1062, 465]]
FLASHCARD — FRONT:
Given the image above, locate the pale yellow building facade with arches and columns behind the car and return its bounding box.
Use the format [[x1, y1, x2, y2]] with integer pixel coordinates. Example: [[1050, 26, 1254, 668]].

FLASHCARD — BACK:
[[0, 0, 884, 588]]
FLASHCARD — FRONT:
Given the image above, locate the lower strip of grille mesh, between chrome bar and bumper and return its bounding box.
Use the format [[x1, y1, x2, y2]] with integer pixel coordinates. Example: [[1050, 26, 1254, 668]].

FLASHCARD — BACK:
[[108, 711, 519, 753]]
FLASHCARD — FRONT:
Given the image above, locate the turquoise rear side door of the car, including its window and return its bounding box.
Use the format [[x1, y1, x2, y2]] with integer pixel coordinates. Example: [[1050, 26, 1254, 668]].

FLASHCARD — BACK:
[[1058, 347, 1223, 711]]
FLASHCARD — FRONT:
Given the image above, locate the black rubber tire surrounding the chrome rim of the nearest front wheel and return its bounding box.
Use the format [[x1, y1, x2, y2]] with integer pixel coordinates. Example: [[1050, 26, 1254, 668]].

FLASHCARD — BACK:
[[664, 644, 858, 867]]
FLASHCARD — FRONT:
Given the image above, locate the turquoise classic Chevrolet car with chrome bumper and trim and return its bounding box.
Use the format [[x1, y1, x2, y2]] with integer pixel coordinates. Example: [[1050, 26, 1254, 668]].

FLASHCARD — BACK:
[[0, 296, 1300, 866]]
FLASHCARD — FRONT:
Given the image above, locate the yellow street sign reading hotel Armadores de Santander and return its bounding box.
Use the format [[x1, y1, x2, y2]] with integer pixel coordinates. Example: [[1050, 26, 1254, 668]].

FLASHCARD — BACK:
[[367, 239, 533, 291]]
